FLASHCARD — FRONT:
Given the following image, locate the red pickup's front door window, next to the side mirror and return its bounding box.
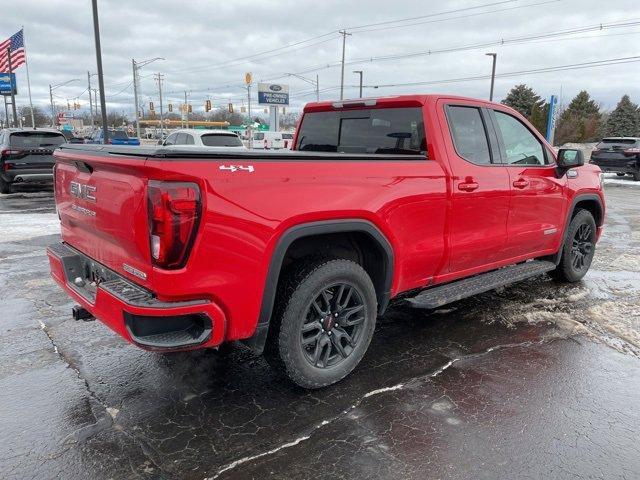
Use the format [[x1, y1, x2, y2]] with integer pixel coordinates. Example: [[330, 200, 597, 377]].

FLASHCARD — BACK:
[[494, 110, 547, 165]]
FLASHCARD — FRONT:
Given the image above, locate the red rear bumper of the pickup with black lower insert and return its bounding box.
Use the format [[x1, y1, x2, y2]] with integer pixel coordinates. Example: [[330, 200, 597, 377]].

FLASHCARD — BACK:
[[47, 243, 226, 351]]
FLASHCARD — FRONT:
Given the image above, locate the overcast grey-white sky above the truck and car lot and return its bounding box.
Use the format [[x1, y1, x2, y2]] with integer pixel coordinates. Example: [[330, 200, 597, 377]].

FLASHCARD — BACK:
[[0, 0, 640, 117]]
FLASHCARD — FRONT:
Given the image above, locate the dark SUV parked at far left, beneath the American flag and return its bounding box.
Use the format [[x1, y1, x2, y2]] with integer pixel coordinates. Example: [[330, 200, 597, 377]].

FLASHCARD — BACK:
[[0, 128, 66, 193]]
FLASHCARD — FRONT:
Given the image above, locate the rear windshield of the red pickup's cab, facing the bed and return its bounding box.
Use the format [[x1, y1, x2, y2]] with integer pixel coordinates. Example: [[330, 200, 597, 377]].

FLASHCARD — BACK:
[[296, 108, 427, 155]]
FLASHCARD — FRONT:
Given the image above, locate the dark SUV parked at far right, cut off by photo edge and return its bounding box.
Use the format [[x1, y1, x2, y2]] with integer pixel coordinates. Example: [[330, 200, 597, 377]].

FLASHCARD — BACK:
[[590, 137, 640, 182]]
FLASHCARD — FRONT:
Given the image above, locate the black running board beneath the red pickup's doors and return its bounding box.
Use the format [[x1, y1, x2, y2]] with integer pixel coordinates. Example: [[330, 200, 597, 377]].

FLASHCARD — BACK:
[[407, 260, 556, 309]]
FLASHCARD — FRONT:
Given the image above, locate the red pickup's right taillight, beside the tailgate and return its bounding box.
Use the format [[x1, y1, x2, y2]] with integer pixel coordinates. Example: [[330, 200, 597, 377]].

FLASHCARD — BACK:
[[147, 180, 202, 269]]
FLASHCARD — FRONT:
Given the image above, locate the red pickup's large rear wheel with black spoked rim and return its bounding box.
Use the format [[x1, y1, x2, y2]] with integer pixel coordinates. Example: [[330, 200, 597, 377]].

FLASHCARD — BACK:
[[264, 259, 377, 389]]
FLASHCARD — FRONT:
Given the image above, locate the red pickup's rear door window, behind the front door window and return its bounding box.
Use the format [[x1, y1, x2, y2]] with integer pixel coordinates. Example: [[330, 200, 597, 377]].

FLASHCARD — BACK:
[[447, 106, 491, 165]]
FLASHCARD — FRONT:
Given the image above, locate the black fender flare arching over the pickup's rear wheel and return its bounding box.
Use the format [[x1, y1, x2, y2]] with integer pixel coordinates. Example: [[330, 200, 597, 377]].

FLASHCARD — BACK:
[[243, 219, 394, 354]]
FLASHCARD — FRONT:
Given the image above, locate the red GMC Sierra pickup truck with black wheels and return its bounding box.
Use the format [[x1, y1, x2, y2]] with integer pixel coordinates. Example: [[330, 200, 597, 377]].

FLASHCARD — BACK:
[[48, 95, 605, 388]]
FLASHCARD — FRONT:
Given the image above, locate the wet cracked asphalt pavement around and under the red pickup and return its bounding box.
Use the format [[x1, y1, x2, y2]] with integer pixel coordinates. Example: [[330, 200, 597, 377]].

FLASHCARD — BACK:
[[0, 181, 640, 480]]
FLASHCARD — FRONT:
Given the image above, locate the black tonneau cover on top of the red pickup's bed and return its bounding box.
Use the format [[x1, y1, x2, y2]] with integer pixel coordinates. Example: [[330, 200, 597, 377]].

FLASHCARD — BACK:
[[58, 143, 426, 161]]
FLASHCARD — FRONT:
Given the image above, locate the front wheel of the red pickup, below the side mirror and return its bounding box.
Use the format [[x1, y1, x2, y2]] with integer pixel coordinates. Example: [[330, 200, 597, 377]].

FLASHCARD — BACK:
[[551, 210, 596, 283]]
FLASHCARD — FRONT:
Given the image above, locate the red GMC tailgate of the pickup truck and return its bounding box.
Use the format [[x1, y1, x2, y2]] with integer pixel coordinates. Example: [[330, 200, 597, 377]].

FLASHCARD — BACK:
[[54, 150, 151, 285]]
